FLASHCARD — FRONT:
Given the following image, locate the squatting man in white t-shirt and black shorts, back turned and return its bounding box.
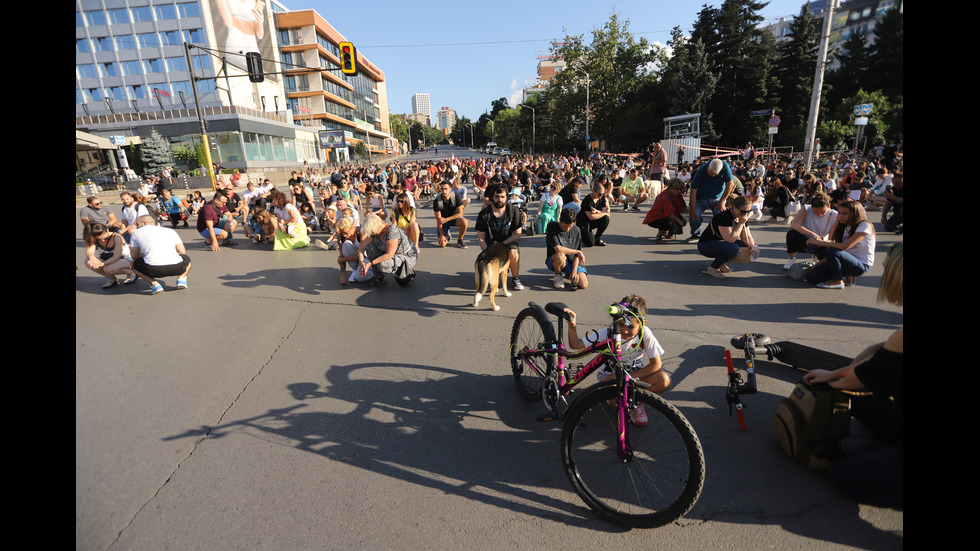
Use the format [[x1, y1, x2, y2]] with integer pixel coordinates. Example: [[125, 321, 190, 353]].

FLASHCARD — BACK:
[[129, 215, 191, 295]]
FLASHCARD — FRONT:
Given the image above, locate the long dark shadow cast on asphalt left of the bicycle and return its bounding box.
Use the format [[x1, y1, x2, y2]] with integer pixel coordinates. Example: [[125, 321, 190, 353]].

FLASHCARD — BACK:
[[164, 363, 623, 533]]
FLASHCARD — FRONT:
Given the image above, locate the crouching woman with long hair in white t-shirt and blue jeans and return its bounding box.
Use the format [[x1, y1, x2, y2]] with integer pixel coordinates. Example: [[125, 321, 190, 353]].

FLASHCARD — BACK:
[[806, 199, 875, 289]]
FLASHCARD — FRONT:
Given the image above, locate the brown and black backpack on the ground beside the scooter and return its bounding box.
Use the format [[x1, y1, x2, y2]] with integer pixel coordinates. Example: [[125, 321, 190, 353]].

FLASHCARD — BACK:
[[773, 381, 862, 470]]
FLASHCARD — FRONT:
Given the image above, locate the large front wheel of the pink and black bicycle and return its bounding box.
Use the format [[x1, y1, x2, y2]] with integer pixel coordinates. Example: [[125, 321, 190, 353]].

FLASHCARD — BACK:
[[561, 387, 704, 528]]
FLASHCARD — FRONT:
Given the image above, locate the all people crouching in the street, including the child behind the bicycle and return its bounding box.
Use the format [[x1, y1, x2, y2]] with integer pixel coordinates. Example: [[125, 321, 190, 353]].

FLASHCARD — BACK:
[[79, 139, 904, 506]]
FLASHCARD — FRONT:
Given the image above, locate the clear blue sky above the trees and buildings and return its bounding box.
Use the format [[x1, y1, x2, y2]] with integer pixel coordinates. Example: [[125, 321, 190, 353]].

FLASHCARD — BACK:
[[280, 0, 805, 123]]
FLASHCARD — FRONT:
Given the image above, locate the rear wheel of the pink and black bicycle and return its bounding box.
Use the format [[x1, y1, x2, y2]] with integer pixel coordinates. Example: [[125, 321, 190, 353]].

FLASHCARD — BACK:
[[510, 308, 556, 401]]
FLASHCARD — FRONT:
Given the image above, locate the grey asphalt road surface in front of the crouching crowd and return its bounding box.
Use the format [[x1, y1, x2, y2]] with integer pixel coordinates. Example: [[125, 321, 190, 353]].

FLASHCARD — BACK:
[[75, 169, 904, 550]]
